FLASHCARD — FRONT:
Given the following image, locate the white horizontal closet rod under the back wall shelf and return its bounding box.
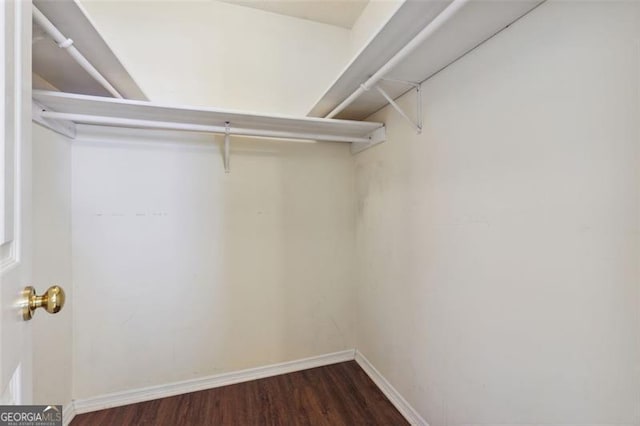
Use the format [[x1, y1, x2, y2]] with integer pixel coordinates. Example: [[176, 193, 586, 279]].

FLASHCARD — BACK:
[[39, 110, 371, 143]]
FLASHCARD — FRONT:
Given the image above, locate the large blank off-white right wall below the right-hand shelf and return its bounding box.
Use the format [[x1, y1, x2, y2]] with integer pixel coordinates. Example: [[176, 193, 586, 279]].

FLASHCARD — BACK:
[[356, 2, 640, 426]]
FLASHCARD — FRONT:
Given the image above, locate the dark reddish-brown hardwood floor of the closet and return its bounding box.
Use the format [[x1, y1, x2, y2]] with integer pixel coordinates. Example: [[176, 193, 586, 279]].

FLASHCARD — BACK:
[[71, 361, 408, 426]]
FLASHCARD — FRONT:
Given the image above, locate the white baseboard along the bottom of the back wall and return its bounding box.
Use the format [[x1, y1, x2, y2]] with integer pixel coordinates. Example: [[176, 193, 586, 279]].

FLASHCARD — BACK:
[[72, 349, 356, 415]]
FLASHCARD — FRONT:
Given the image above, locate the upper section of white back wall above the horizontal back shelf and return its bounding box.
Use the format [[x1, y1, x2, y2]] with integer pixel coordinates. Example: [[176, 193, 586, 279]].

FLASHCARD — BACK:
[[82, 0, 350, 114]]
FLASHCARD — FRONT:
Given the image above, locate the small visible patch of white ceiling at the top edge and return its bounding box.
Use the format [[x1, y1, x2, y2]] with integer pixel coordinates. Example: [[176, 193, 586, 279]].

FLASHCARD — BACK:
[[221, 0, 369, 29]]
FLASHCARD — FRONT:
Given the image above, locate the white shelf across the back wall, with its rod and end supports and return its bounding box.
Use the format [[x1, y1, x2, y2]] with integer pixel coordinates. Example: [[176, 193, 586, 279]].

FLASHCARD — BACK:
[[33, 90, 385, 148]]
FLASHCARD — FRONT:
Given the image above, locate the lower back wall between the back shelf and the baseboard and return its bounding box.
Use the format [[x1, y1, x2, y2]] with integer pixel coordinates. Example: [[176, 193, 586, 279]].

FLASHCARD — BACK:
[[72, 131, 354, 399]]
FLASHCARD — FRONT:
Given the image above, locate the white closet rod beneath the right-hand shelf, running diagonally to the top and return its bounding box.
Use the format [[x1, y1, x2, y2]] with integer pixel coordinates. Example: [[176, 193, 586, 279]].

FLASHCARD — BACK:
[[325, 0, 470, 118]]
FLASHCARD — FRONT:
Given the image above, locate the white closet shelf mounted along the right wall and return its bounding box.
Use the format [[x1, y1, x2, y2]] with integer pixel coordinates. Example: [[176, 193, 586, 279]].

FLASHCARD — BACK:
[[309, 0, 544, 120]]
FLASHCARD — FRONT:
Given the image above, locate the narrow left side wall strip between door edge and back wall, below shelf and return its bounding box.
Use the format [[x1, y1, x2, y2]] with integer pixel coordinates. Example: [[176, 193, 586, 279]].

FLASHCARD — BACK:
[[31, 124, 73, 405]]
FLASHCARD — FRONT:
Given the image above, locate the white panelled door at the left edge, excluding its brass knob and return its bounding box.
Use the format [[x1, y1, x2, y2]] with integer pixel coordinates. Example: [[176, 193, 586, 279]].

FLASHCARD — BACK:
[[0, 0, 33, 404]]
